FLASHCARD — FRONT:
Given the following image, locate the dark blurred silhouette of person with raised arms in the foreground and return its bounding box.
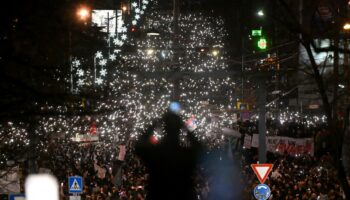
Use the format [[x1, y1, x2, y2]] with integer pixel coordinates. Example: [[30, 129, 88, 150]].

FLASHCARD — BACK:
[[135, 112, 201, 200]]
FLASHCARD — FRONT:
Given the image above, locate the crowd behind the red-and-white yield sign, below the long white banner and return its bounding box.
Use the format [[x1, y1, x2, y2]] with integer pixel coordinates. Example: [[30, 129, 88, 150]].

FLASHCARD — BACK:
[[242, 151, 345, 200]]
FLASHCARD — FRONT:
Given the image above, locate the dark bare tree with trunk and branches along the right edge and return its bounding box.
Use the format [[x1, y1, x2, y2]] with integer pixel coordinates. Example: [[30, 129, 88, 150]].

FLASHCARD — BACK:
[[271, 0, 350, 198]]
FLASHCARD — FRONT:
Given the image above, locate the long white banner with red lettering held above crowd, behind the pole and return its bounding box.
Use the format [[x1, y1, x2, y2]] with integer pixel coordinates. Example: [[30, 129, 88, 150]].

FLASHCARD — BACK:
[[252, 134, 314, 156]]
